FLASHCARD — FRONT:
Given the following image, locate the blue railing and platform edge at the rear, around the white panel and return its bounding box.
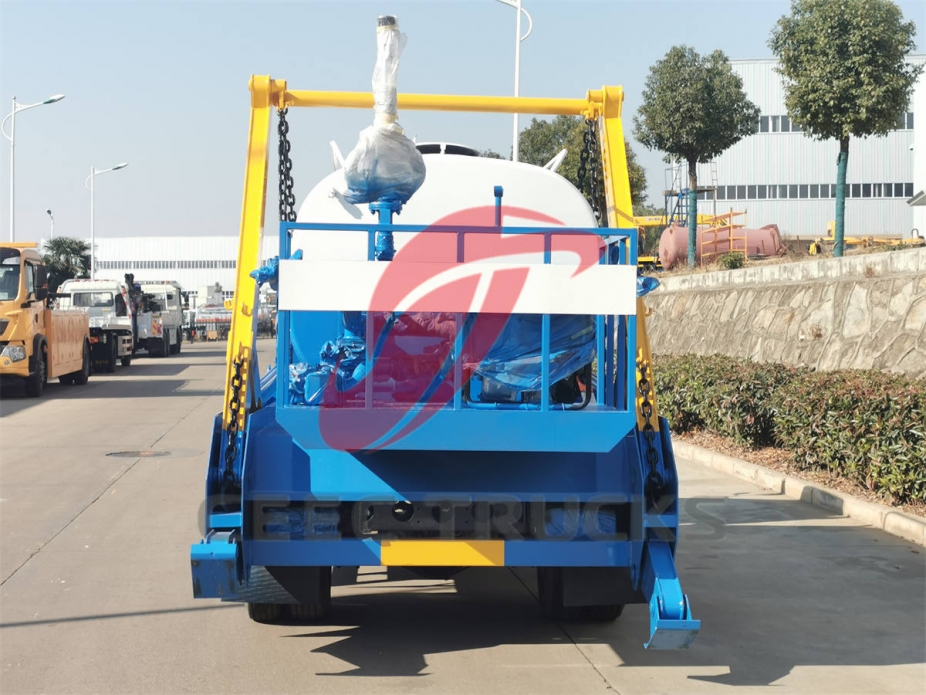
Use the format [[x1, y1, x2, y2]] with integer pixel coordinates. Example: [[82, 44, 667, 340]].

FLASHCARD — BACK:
[[276, 222, 637, 453]]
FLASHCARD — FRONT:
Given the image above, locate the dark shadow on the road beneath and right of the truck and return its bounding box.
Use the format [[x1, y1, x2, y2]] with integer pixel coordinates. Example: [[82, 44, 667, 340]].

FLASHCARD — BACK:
[[272, 495, 926, 686]]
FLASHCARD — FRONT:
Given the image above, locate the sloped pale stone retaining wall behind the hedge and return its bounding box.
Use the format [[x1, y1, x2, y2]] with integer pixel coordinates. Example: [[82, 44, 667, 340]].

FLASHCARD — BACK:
[[647, 248, 926, 378]]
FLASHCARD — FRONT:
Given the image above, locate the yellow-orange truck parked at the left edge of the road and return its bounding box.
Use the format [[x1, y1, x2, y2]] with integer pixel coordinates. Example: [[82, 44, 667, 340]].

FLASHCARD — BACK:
[[0, 242, 90, 397]]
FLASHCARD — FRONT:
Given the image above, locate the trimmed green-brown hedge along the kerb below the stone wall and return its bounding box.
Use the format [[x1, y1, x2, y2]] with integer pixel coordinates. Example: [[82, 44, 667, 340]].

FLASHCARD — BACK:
[[655, 355, 926, 502]]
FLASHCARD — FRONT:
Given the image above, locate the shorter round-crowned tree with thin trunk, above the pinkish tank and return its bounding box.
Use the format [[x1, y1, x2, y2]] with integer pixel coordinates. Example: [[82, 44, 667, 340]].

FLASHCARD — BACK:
[[633, 46, 759, 267]]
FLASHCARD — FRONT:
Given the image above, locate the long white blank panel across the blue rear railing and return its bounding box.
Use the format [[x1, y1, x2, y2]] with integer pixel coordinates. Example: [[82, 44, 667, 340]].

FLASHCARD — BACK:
[[279, 260, 636, 315]]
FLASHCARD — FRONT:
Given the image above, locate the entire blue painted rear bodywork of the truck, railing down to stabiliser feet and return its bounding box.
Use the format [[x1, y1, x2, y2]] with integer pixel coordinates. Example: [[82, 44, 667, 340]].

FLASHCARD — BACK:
[[191, 215, 700, 649]]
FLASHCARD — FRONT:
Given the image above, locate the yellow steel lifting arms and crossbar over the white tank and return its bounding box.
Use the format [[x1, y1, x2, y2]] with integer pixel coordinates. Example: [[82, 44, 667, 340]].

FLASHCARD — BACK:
[[222, 75, 649, 431]]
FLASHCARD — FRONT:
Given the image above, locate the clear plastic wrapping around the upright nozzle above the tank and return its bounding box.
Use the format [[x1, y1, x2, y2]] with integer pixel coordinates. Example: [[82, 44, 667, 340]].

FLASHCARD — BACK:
[[344, 16, 425, 206]]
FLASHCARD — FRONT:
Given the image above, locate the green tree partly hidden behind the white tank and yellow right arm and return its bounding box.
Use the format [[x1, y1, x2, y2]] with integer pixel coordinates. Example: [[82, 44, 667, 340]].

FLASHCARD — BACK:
[[518, 116, 646, 204]]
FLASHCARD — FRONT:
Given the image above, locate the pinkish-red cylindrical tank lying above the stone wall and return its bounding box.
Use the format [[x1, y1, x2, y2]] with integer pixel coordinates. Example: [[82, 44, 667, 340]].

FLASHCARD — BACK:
[[659, 224, 783, 270]]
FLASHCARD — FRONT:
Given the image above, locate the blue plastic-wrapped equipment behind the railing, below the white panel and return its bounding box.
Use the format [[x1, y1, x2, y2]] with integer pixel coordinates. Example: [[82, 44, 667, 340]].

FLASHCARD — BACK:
[[289, 312, 595, 407]]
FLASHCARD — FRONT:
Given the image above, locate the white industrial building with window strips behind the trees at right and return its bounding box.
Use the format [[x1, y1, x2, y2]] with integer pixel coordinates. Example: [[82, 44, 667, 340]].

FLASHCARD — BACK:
[[684, 55, 926, 237]]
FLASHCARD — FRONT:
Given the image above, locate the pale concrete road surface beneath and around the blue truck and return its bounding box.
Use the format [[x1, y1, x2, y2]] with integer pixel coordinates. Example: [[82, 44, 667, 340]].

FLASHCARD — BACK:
[[0, 343, 926, 694]]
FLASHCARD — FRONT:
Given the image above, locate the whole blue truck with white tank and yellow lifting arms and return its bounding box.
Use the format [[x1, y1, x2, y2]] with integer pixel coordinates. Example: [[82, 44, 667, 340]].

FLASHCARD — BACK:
[[191, 17, 700, 649]]
